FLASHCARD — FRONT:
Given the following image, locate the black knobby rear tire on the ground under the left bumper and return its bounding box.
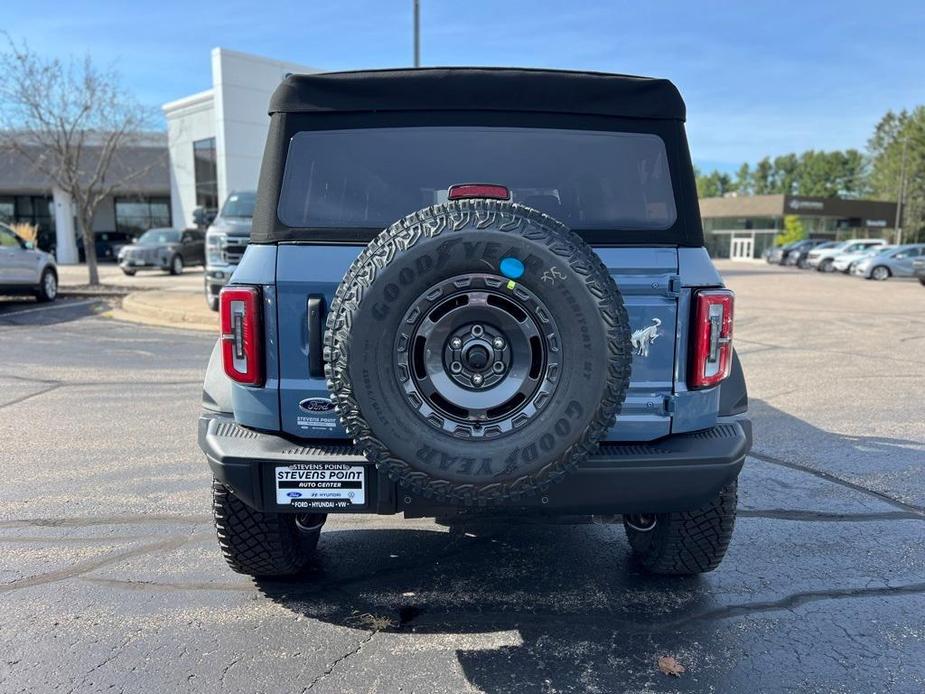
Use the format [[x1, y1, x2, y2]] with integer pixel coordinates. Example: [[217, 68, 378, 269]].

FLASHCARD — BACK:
[[212, 479, 324, 577]]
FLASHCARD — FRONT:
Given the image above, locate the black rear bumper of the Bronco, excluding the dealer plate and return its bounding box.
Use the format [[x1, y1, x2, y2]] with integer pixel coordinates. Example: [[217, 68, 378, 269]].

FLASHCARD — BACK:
[[199, 412, 752, 516]]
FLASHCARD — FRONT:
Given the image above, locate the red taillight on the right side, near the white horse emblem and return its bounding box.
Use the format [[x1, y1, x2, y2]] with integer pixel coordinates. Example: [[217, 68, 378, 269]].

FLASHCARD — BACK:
[[687, 289, 735, 388]]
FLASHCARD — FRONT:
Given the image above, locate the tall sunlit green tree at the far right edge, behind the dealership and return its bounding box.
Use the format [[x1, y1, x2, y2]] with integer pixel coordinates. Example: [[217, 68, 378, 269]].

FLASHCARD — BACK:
[[867, 106, 925, 242]]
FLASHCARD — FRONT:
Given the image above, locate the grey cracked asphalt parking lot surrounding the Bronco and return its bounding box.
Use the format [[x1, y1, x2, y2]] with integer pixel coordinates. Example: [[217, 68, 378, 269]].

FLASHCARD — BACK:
[[0, 263, 925, 692]]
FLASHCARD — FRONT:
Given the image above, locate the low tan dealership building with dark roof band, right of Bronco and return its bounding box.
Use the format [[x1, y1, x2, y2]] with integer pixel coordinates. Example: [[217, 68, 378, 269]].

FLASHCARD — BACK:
[[700, 195, 896, 260]]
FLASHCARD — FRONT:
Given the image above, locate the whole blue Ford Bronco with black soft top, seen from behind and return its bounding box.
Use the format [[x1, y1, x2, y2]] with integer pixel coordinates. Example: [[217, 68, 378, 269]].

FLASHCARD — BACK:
[[199, 68, 751, 576]]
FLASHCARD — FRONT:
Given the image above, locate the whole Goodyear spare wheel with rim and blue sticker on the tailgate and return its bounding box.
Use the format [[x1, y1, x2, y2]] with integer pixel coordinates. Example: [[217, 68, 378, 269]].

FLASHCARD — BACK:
[[324, 199, 631, 506]]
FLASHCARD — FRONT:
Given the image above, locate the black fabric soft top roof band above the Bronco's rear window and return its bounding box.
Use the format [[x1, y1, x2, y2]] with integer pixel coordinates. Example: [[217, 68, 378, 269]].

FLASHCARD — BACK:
[[270, 67, 685, 121]]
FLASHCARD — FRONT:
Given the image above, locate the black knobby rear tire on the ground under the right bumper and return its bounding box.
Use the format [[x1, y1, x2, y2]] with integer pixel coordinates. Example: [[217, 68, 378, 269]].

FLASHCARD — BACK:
[[623, 481, 737, 576]]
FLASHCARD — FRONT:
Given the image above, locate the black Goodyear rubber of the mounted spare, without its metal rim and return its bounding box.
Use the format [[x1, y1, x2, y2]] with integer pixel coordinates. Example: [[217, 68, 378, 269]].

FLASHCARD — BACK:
[[324, 200, 632, 506]]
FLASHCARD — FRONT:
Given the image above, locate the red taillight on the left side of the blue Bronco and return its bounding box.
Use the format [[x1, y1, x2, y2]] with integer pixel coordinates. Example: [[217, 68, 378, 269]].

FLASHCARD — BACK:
[[219, 287, 263, 386]]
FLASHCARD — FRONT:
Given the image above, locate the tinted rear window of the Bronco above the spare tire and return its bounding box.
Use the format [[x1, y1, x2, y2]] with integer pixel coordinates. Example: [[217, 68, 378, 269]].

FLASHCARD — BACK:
[[278, 127, 677, 230]]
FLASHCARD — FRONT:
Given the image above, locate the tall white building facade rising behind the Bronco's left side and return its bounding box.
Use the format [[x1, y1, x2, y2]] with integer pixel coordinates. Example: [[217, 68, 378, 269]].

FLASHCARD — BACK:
[[162, 48, 318, 229]]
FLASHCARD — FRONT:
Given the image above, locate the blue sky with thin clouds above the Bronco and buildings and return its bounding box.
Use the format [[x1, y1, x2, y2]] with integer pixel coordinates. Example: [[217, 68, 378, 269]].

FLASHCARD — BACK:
[[0, 0, 925, 169]]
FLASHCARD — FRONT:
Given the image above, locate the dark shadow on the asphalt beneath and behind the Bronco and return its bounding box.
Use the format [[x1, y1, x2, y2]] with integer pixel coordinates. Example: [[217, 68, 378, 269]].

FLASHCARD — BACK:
[[256, 520, 729, 692]]
